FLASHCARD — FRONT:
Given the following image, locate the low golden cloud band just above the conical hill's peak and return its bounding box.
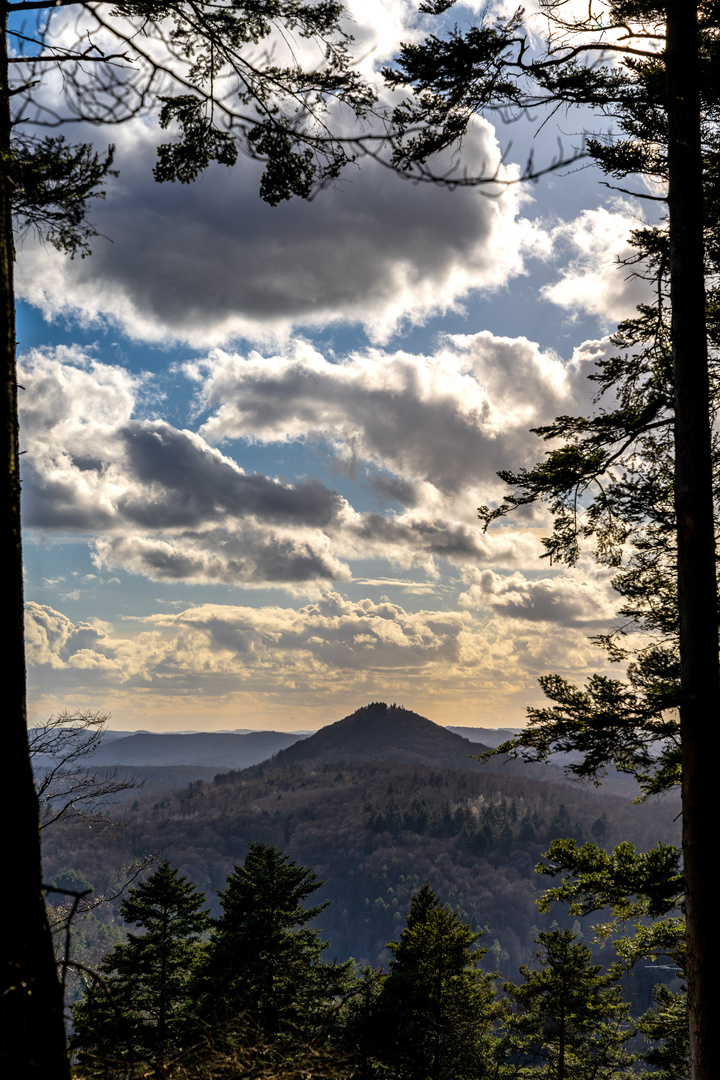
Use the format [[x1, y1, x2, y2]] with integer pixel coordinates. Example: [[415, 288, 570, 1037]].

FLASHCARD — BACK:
[[27, 592, 617, 727]]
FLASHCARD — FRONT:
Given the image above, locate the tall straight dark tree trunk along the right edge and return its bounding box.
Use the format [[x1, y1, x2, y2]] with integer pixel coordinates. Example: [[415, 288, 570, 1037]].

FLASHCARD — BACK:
[[666, 8, 720, 1080]]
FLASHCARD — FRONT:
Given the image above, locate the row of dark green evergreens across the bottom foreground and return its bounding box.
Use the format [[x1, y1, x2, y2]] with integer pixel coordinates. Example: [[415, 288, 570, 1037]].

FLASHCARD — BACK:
[[59, 841, 688, 1080]]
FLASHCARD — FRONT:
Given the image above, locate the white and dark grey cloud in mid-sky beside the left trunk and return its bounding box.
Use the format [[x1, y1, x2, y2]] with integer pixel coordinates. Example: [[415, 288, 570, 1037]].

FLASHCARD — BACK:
[[21, 350, 349, 584]]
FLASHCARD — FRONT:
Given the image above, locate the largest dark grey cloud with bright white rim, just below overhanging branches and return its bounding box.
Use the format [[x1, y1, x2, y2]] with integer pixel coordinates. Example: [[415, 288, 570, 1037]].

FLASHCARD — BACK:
[[17, 102, 534, 347]]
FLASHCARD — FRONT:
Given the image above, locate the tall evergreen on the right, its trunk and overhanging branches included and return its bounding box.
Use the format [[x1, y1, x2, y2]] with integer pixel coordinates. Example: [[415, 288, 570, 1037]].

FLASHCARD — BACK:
[[388, 8, 720, 1080]]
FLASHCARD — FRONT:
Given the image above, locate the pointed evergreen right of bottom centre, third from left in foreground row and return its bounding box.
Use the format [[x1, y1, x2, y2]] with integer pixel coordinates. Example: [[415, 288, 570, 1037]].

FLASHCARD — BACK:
[[370, 882, 500, 1080]]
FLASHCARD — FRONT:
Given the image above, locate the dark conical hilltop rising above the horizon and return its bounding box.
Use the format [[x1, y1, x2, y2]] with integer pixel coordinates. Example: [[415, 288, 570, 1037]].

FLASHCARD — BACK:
[[264, 701, 496, 769]]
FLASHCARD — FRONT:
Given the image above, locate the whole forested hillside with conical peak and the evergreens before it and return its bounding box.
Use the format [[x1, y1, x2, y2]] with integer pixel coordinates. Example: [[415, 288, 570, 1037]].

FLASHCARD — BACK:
[[44, 703, 687, 1080]]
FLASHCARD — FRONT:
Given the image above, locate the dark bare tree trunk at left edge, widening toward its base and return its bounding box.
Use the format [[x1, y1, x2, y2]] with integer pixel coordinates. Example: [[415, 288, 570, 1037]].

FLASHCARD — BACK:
[[0, 4, 70, 1080]]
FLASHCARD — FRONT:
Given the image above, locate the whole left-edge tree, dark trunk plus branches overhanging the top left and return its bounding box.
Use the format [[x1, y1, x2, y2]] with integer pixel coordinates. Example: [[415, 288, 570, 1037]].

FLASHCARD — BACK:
[[0, 6, 373, 1078]]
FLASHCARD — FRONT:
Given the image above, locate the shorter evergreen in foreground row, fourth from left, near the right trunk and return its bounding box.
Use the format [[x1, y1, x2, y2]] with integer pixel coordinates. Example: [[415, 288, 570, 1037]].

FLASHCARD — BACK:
[[504, 930, 633, 1080]]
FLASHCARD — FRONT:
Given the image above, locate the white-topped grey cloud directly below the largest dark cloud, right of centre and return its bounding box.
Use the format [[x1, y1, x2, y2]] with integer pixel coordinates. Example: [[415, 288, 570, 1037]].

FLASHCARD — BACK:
[[186, 332, 585, 496]]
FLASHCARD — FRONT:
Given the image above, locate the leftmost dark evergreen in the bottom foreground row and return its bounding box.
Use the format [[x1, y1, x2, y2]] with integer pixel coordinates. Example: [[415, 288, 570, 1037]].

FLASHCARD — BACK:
[[72, 861, 210, 1075]]
